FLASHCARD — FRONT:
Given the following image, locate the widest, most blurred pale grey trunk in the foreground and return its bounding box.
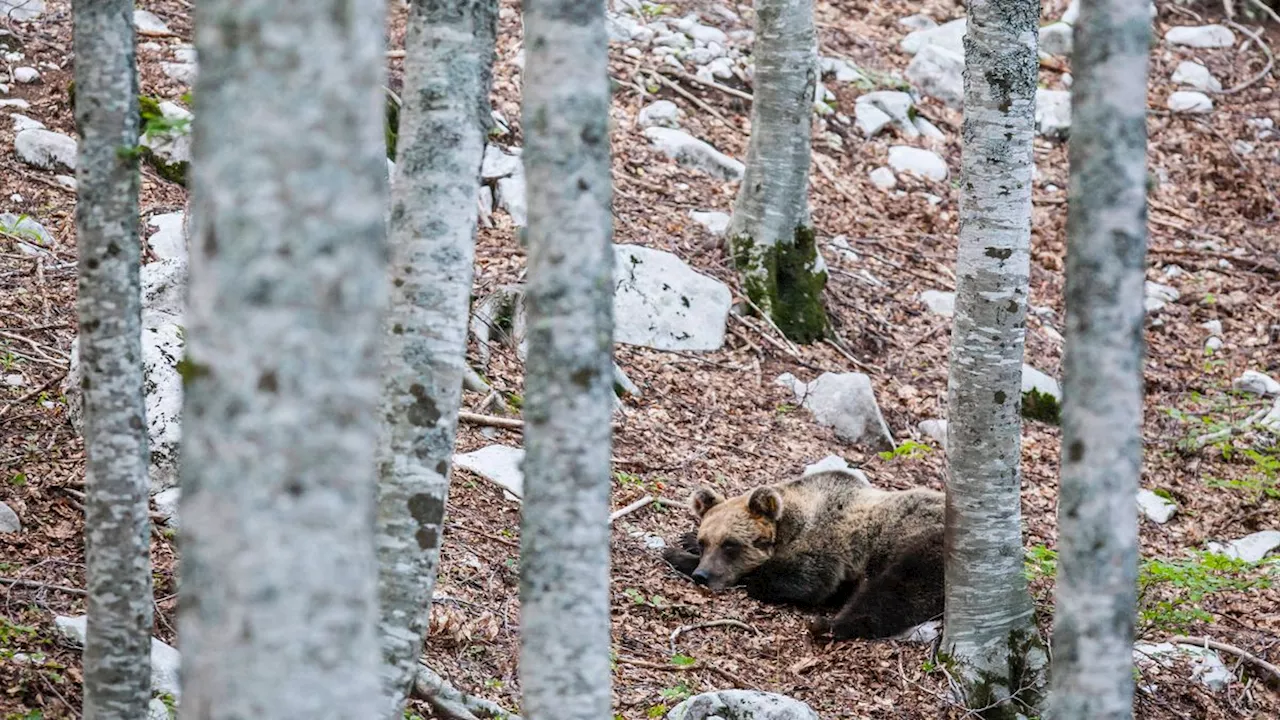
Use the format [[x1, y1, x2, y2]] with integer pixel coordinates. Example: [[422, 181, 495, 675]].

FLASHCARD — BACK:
[[179, 0, 387, 720]]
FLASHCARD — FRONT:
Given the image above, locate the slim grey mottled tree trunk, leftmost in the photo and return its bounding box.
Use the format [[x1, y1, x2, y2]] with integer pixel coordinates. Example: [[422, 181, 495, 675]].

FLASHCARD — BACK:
[[72, 0, 152, 720]]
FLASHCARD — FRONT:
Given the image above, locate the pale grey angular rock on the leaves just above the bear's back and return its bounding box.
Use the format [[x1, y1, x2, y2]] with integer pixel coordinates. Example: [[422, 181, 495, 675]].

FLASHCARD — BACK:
[[776, 373, 893, 450]]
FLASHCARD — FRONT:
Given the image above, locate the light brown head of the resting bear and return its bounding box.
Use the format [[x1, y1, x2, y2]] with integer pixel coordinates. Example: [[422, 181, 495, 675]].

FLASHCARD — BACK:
[[692, 487, 782, 591]]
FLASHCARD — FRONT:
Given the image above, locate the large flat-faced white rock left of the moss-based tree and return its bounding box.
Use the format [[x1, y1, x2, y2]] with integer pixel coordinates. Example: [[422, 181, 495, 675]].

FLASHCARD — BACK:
[[613, 245, 732, 351]]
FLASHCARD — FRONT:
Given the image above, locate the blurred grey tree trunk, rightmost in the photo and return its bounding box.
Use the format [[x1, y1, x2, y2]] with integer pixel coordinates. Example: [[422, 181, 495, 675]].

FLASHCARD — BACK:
[[1050, 0, 1151, 720]]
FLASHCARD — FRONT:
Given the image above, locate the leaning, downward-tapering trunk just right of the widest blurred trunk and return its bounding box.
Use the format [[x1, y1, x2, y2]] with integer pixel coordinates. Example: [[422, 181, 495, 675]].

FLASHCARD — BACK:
[[378, 0, 498, 720]]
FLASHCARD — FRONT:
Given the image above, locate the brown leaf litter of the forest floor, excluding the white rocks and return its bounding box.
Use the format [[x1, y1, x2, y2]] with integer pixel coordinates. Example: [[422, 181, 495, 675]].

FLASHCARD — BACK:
[[0, 0, 1280, 720]]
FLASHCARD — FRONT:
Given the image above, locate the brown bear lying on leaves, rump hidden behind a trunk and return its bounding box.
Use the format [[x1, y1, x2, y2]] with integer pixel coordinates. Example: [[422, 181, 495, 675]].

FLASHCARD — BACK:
[[663, 470, 945, 639]]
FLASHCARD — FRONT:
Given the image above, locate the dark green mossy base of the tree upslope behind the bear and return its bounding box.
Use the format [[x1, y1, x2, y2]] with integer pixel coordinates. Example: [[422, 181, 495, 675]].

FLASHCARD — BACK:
[[731, 225, 829, 345]]
